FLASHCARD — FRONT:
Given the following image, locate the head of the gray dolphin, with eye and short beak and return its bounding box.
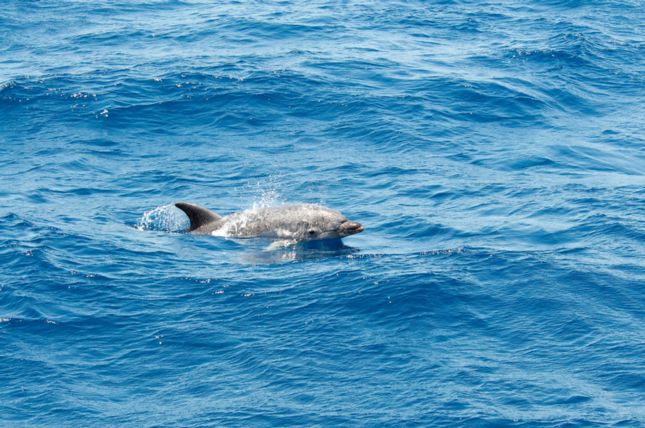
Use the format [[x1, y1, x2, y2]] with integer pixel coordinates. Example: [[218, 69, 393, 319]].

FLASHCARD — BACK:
[[299, 205, 363, 241]]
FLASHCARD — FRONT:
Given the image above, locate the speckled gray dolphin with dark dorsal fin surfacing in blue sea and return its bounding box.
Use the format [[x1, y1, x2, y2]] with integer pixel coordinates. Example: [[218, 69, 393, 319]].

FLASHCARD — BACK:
[[175, 202, 363, 241]]
